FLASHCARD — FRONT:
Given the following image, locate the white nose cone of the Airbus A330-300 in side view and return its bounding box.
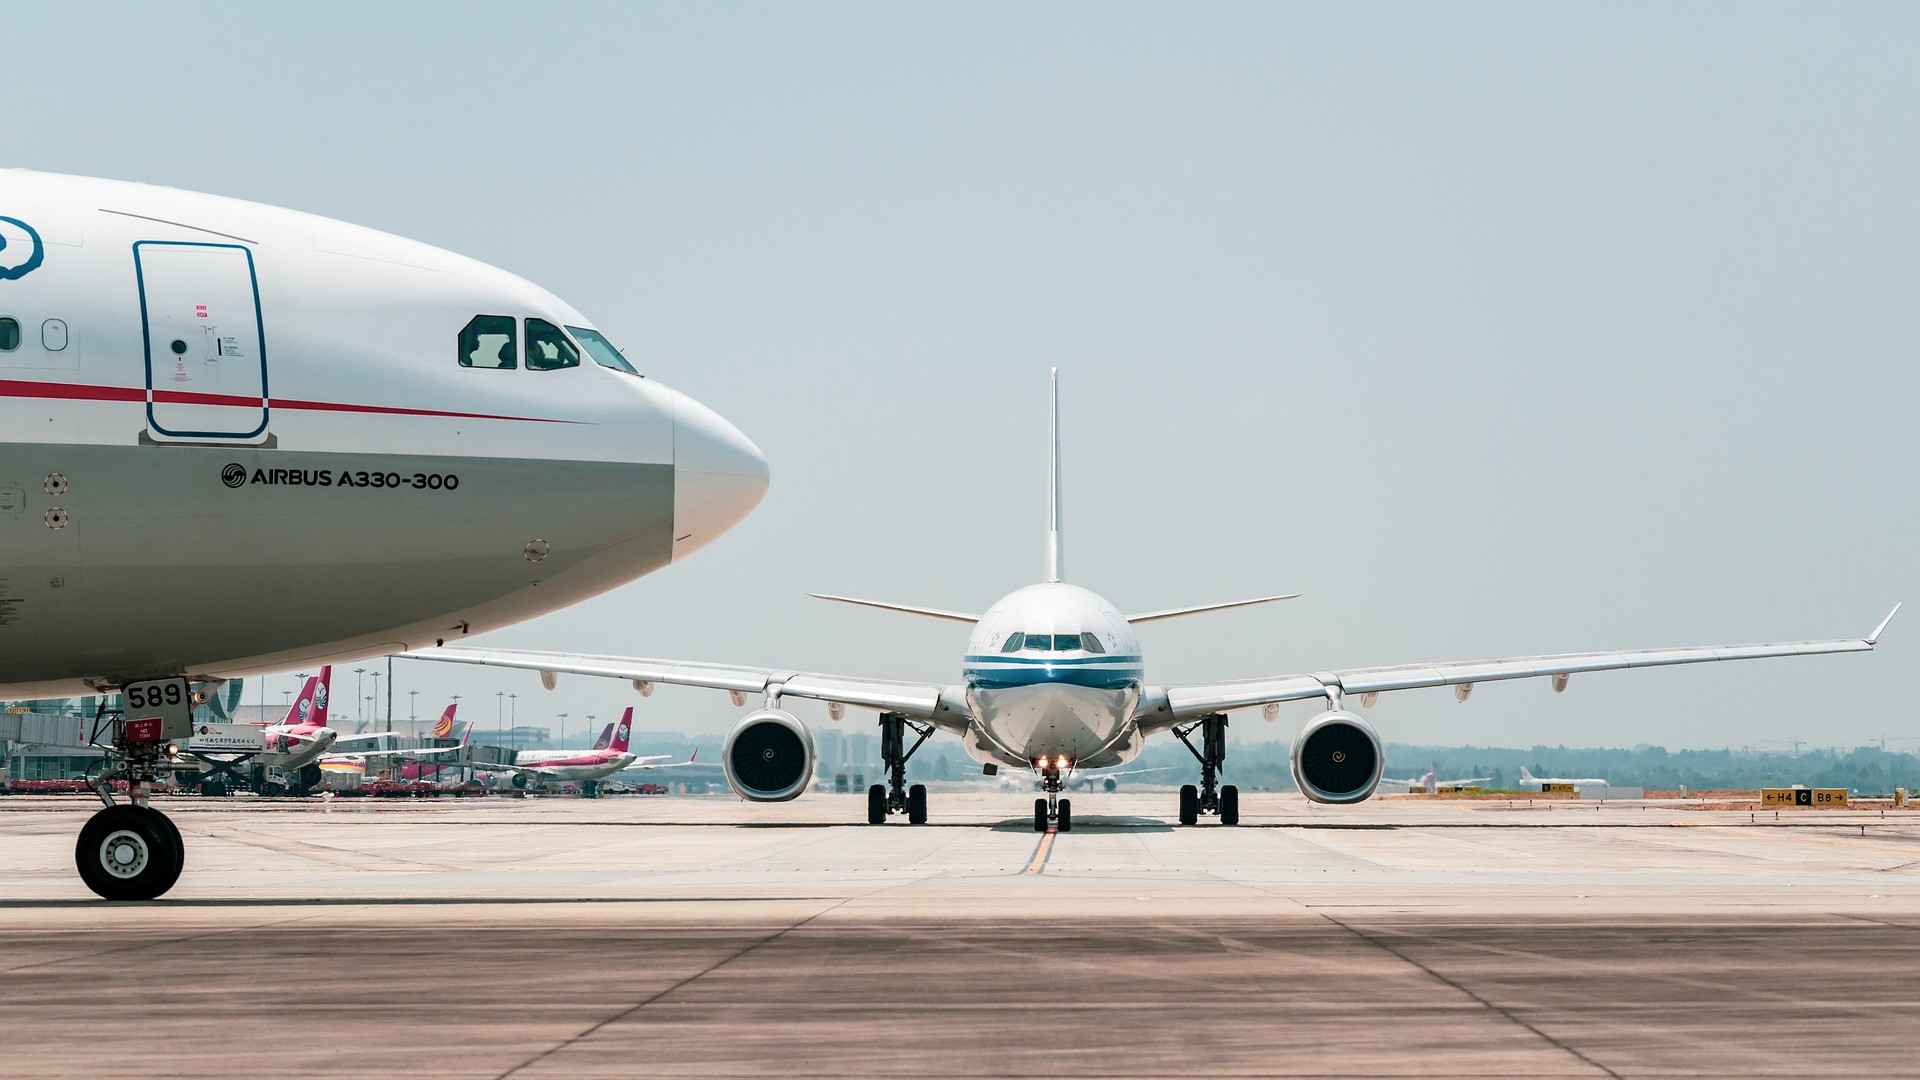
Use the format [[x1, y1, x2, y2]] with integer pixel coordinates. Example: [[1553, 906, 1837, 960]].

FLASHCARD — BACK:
[[674, 392, 766, 563]]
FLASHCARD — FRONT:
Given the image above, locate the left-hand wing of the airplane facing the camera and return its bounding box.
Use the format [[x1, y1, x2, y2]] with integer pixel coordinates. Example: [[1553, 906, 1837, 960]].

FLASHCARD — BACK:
[[399, 646, 966, 730]]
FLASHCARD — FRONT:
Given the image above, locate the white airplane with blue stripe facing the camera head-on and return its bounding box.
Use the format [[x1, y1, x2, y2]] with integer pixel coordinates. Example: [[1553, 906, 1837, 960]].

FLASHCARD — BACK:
[[405, 369, 1899, 832]]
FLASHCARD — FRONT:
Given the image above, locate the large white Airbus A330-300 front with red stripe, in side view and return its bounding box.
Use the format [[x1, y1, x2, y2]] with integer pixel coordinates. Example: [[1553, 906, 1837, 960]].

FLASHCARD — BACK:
[[0, 169, 768, 899]]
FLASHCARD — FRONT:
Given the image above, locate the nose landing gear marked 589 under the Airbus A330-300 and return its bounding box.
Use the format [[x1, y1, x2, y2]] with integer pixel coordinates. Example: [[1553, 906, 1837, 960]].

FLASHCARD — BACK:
[[73, 722, 186, 899]]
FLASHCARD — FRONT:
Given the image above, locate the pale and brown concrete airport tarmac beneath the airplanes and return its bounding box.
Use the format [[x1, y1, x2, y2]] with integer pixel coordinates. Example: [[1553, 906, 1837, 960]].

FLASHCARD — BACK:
[[0, 792, 1920, 1078]]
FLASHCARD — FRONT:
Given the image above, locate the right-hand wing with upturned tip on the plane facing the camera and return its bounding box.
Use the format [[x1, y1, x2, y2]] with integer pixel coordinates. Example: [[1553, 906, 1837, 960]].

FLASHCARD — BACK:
[[1140, 605, 1899, 730]]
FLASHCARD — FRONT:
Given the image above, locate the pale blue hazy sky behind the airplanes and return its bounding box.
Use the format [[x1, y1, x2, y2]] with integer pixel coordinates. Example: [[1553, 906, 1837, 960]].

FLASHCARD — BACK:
[[11, 4, 1920, 746]]
